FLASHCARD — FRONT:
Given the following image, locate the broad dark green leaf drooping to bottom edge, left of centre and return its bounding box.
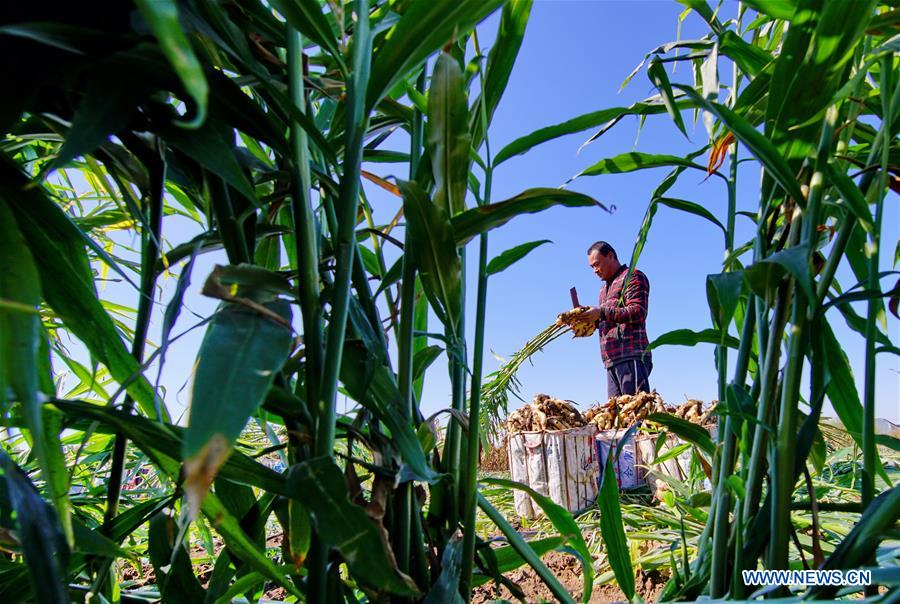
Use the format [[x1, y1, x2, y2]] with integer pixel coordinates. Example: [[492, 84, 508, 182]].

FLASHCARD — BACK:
[[288, 457, 419, 596]]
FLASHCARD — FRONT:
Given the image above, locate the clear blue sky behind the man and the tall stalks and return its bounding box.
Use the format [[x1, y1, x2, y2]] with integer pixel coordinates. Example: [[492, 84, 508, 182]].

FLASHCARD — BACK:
[[81, 0, 900, 421]]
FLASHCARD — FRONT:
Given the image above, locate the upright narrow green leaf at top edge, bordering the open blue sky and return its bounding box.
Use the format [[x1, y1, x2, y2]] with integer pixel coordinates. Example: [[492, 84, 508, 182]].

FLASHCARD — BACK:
[[469, 0, 533, 149]]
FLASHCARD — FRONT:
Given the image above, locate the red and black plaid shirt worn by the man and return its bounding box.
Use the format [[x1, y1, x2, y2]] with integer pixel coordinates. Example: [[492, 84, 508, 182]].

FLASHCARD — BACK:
[[599, 264, 650, 367]]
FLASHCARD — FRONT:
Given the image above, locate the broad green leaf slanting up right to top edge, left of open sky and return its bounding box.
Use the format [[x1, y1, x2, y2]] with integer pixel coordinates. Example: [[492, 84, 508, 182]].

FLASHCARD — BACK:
[[366, 0, 503, 111]]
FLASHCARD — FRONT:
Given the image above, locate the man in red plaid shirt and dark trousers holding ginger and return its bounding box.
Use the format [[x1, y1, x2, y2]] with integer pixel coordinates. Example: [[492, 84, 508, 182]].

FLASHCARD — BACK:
[[586, 241, 653, 398]]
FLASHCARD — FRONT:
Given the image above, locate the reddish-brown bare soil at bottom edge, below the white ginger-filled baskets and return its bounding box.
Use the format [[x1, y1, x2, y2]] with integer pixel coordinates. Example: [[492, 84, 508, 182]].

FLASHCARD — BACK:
[[472, 552, 668, 604]]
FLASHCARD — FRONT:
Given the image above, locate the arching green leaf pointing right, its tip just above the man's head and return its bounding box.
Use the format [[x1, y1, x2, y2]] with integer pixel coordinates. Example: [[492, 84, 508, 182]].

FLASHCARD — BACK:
[[452, 188, 606, 245]]
